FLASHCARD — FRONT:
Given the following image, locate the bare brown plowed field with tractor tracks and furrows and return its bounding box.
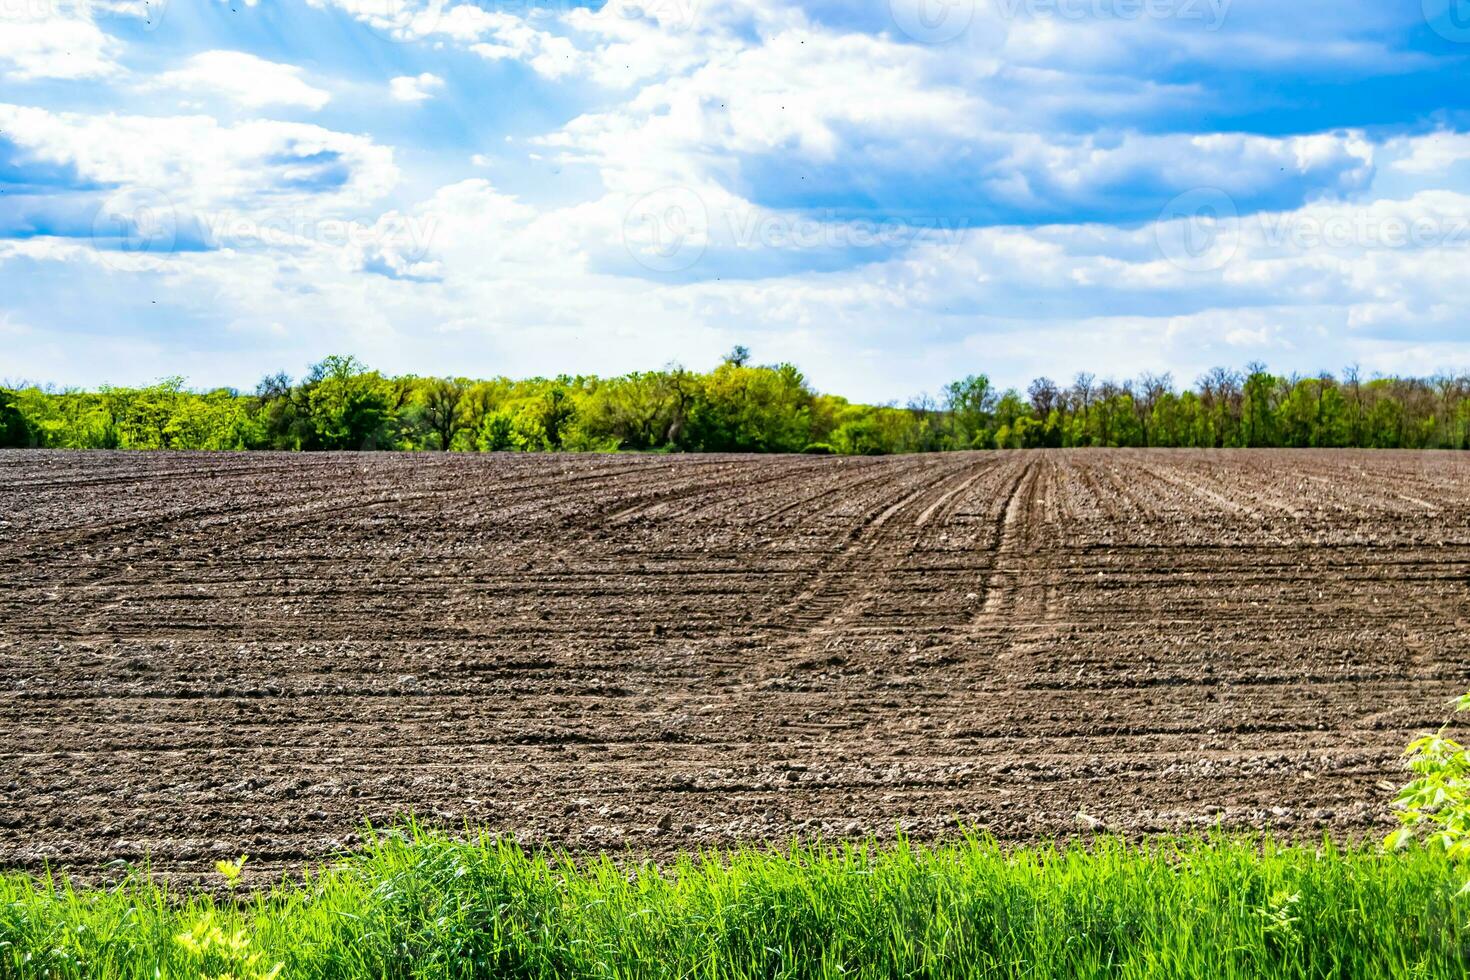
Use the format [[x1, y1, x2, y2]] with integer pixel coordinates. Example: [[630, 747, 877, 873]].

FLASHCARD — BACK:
[[0, 451, 1470, 870]]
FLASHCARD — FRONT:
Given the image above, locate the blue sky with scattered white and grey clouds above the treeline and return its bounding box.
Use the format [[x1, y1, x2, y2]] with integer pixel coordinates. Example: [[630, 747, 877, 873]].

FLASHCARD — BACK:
[[0, 0, 1470, 403]]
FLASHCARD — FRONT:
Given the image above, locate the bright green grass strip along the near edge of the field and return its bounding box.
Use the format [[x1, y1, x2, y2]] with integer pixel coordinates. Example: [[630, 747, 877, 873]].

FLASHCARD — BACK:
[[0, 830, 1470, 980]]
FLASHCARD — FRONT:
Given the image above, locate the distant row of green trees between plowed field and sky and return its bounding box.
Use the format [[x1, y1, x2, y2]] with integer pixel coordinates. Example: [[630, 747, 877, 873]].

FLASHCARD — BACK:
[[0, 347, 1470, 455]]
